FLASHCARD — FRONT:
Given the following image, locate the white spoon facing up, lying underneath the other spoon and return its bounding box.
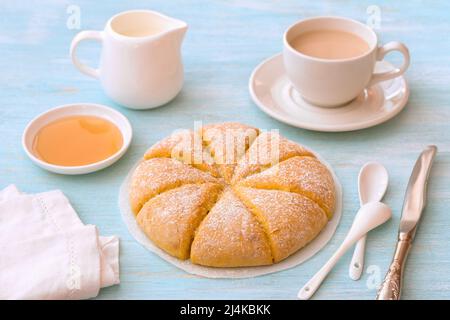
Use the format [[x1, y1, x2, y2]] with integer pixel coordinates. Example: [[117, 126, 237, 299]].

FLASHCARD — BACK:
[[349, 162, 389, 280]]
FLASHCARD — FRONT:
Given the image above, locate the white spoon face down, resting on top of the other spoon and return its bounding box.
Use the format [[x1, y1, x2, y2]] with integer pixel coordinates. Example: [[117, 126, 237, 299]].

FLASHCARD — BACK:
[[297, 202, 392, 300]]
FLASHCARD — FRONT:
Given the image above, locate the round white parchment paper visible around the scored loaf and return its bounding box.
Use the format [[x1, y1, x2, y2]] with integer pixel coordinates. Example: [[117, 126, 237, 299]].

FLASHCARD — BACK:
[[119, 154, 342, 278]]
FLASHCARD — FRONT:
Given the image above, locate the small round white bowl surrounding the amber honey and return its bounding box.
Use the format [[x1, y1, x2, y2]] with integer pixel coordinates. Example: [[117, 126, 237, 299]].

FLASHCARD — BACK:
[[22, 103, 133, 175]]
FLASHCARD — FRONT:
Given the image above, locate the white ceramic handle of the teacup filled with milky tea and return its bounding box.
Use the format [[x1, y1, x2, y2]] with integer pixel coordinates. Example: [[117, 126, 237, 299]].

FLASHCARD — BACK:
[[368, 41, 409, 87]]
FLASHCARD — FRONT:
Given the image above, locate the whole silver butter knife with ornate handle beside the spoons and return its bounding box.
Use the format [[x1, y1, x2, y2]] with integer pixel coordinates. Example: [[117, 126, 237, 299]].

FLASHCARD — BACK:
[[377, 146, 437, 300]]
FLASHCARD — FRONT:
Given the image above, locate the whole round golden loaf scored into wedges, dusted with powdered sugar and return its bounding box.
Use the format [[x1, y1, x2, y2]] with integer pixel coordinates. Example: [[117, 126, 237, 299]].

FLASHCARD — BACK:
[[129, 123, 336, 267]]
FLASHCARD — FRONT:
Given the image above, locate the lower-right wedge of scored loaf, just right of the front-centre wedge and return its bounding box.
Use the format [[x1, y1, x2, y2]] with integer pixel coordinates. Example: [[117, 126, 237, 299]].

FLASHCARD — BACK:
[[235, 187, 328, 263]]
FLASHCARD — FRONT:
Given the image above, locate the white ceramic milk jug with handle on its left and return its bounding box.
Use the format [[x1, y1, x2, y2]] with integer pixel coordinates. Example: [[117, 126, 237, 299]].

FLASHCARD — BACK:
[[70, 10, 187, 109]]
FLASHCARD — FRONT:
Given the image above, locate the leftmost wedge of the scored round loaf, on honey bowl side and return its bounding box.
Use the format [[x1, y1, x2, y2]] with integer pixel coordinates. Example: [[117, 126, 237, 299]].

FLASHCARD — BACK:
[[130, 158, 219, 214]]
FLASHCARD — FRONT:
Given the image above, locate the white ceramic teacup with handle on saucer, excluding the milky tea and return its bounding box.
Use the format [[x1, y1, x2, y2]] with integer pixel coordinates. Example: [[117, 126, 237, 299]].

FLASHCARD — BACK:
[[283, 17, 409, 107]]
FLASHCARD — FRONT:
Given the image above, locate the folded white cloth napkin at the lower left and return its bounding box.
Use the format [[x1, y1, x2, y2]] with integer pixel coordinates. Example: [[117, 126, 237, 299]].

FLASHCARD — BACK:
[[0, 185, 120, 299]]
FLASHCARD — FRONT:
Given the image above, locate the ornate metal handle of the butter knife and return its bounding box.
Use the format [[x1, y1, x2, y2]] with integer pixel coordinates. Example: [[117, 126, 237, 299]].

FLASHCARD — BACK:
[[377, 237, 411, 300]]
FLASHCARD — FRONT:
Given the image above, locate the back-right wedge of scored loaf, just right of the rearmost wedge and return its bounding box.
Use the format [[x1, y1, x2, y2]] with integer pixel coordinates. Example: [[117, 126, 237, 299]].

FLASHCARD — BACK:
[[233, 131, 314, 182]]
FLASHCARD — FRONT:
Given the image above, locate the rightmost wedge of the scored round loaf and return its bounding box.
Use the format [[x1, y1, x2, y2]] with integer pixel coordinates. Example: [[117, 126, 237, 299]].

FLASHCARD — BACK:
[[238, 157, 336, 219]]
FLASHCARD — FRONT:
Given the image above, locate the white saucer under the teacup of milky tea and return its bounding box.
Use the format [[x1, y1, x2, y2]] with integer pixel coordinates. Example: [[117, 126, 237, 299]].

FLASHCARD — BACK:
[[249, 54, 409, 132]]
